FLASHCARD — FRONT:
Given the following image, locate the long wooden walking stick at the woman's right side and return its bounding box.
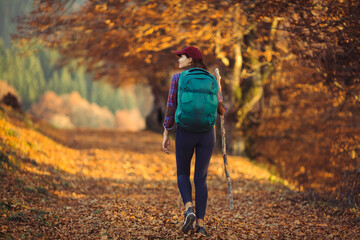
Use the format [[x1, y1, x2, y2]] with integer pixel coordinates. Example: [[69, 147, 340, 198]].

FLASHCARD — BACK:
[[215, 68, 234, 210]]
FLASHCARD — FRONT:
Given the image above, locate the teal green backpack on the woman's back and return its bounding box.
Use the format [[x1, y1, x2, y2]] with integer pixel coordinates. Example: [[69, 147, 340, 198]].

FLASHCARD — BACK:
[[175, 68, 219, 132]]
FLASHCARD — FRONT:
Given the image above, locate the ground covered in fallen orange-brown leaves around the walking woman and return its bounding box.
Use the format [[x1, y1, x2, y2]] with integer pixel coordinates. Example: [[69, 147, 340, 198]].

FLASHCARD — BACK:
[[0, 109, 360, 239]]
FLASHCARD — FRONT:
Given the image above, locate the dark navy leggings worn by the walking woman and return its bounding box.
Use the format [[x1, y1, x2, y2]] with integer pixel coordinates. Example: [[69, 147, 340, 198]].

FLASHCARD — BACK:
[[175, 127, 215, 219]]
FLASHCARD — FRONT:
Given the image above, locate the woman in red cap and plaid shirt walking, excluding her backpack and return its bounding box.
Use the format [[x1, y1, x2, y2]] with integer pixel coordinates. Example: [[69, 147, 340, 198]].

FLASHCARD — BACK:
[[162, 47, 225, 235]]
